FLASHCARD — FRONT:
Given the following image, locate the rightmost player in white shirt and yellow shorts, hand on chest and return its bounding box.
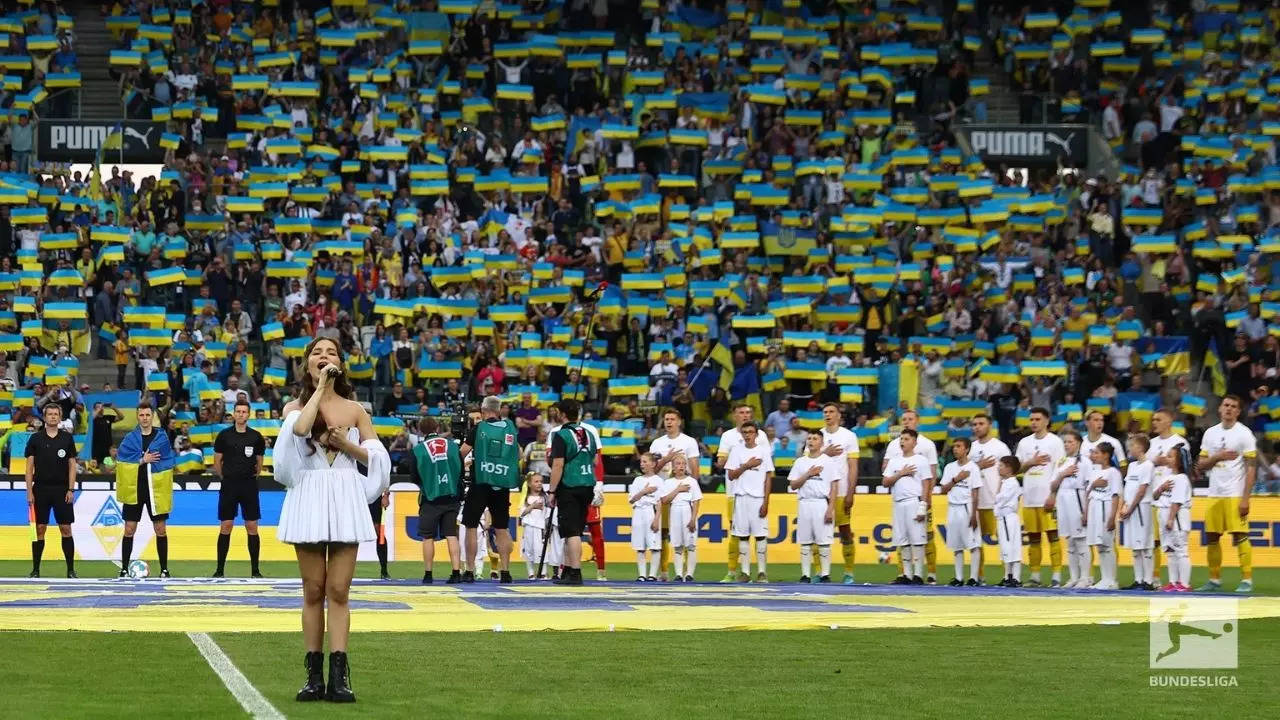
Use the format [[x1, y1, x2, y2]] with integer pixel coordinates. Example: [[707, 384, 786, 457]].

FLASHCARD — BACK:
[[1197, 395, 1258, 592]]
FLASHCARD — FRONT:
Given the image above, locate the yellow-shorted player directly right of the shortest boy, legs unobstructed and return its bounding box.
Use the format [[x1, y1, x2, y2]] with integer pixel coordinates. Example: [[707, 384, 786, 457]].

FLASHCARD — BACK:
[[1014, 407, 1066, 587]]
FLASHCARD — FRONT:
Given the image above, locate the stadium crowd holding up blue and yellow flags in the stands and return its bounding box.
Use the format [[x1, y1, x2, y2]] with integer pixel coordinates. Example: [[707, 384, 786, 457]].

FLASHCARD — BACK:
[[0, 0, 1280, 502]]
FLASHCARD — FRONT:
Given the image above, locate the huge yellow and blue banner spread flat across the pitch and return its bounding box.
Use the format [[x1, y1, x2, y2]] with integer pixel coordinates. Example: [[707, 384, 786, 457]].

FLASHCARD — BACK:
[[0, 579, 1280, 633]]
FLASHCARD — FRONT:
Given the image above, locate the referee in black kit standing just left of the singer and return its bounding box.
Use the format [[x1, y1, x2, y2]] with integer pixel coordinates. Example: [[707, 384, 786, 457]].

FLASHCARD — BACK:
[[214, 400, 266, 578]]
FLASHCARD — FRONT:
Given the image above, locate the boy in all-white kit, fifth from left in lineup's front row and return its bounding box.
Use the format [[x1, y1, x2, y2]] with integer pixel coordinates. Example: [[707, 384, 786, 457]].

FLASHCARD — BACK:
[[881, 429, 933, 585]]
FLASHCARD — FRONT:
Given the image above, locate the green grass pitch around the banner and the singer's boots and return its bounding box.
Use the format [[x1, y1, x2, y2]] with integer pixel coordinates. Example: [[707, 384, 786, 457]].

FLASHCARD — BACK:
[[0, 557, 1280, 720]]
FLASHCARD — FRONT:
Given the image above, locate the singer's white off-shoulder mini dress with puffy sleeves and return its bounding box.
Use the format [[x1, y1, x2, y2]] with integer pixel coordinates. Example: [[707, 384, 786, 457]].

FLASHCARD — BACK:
[[271, 410, 392, 544]]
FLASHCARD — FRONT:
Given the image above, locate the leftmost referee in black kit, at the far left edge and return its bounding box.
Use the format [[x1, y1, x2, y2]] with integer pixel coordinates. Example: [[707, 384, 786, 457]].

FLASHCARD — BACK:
[[27, 402, 77, 578]]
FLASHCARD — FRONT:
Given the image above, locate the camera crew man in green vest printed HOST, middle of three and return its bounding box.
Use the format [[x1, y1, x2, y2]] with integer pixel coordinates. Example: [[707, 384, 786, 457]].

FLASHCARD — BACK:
[[462, 395, 520, 584]]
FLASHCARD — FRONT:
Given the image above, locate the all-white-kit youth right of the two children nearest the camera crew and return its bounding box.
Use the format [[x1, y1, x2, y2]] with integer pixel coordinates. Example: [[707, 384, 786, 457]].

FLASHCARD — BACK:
[[724, 421, 773, 583]]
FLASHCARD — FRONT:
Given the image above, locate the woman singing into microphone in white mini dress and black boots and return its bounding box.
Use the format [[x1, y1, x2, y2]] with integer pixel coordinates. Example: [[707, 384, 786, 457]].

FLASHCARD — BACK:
[[273, 337, 390, 702]]
